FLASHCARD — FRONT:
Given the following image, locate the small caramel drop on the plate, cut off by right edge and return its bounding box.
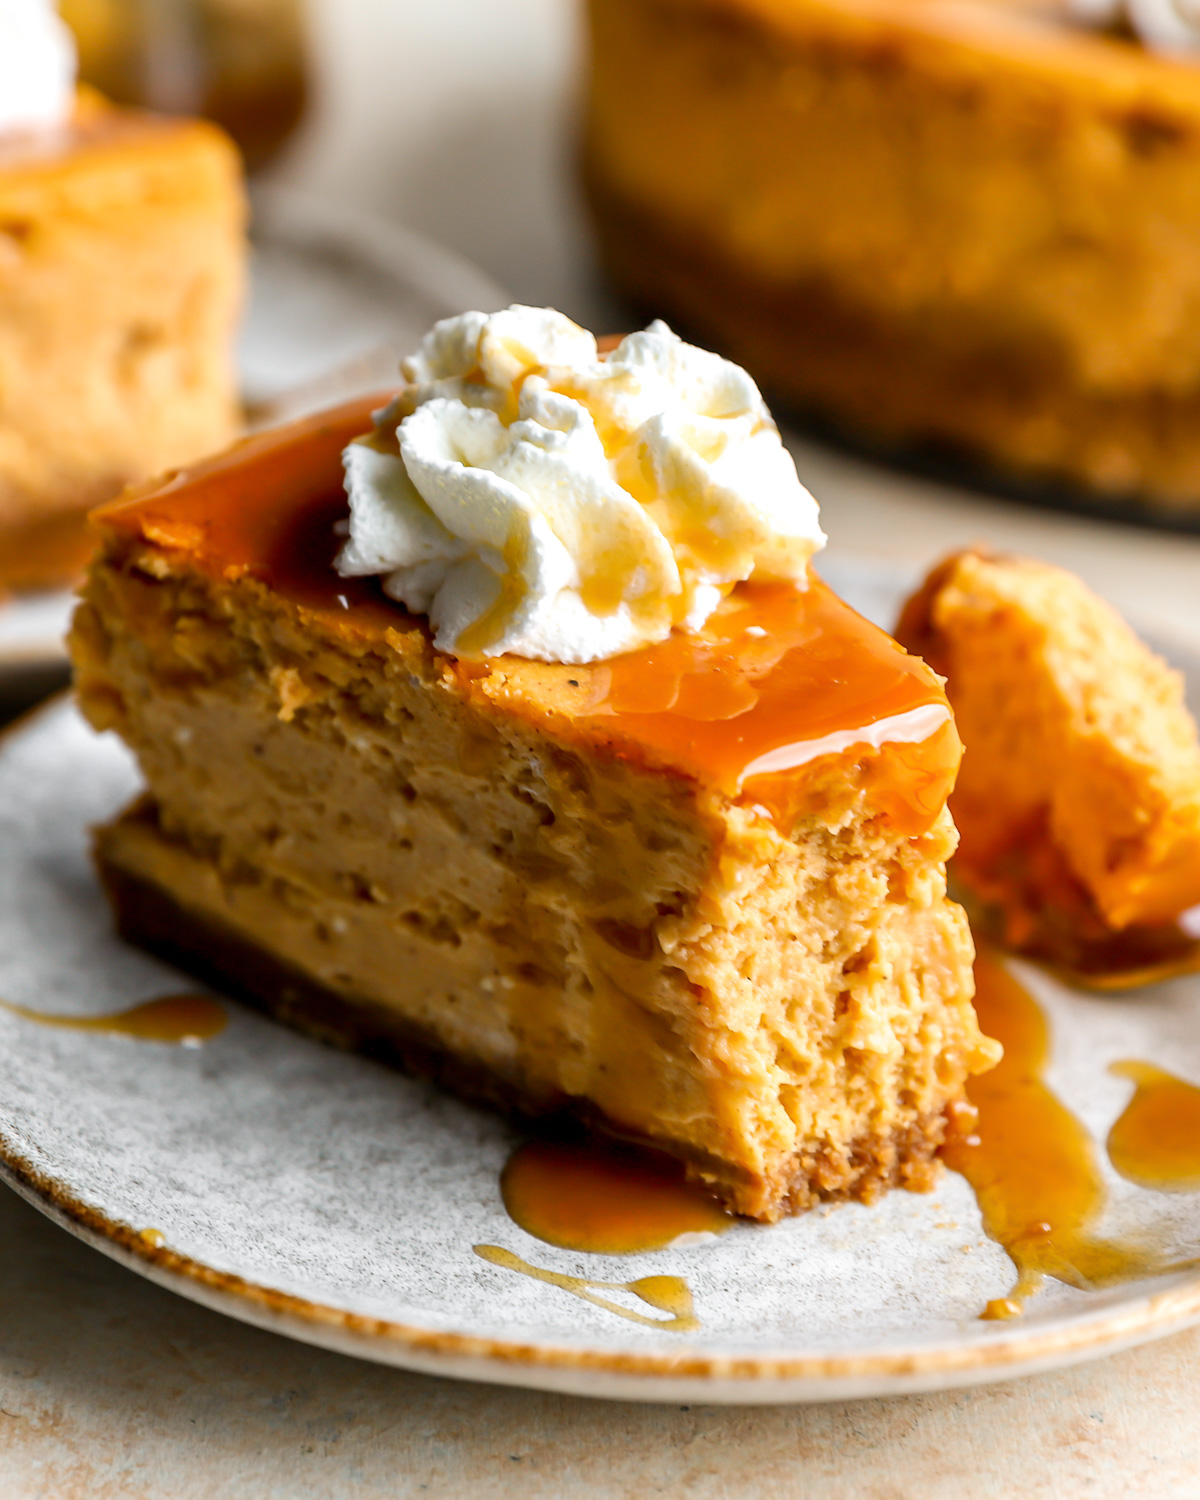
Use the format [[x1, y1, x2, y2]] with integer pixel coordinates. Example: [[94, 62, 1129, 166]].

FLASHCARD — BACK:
[[1109, 1062, 1200, 1193]]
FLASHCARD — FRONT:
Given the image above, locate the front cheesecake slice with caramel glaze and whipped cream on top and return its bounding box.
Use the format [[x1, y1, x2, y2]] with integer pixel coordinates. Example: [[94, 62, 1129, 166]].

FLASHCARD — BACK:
[[72, 309, 998, 1220]]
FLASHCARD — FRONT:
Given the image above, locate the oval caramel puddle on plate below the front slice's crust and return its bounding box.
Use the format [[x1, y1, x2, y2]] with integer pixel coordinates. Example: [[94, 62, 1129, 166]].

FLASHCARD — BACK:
[[500, 1140, 734, 1256]]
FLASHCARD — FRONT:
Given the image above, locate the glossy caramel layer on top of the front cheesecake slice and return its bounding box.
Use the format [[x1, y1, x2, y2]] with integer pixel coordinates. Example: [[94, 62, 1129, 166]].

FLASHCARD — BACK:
[[96, 396, 962, 836]]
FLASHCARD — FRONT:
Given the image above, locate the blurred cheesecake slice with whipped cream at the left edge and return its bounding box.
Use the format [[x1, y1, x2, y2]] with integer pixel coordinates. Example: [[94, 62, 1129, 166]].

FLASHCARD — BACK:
[[0, 0, 245, 591]]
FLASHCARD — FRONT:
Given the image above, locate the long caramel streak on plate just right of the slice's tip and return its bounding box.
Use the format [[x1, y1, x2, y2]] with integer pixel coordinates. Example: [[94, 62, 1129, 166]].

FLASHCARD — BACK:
[[942, 953, 1167, 1319]]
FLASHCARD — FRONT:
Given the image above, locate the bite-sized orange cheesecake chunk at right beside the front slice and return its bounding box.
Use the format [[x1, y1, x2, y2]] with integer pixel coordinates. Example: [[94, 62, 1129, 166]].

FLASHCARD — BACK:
[[897, 551, 1200, 959]]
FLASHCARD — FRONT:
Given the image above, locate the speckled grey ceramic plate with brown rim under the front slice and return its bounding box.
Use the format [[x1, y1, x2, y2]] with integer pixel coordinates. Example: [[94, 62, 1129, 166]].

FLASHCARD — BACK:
[[0, 558, 1200, 1403]]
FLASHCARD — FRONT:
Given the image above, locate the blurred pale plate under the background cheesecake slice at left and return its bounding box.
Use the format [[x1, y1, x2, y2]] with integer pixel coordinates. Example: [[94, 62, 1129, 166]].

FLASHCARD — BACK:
[[0, 191, 509, 675]]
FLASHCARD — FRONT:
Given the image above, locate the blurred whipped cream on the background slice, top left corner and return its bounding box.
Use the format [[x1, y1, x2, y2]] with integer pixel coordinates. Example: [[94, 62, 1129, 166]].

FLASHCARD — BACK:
[[0, 0, 75, 134]]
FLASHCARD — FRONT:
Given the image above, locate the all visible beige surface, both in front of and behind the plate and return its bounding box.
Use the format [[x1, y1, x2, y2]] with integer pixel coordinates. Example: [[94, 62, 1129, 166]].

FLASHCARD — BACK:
[[0, 0, 1200, 1500]]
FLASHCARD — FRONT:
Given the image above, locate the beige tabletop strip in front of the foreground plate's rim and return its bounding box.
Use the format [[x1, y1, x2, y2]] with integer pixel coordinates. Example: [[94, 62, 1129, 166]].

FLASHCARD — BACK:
[[0, 1170, 1200, 1500]]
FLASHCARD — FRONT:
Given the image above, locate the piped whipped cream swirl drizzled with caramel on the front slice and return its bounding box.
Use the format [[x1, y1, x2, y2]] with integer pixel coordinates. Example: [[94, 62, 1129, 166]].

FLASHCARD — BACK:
[[338, 306, 825, 663]]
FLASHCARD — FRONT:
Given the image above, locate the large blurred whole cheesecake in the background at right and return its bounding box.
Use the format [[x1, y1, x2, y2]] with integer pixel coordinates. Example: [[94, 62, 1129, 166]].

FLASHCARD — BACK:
[[587, 0, 1200, 518]]
